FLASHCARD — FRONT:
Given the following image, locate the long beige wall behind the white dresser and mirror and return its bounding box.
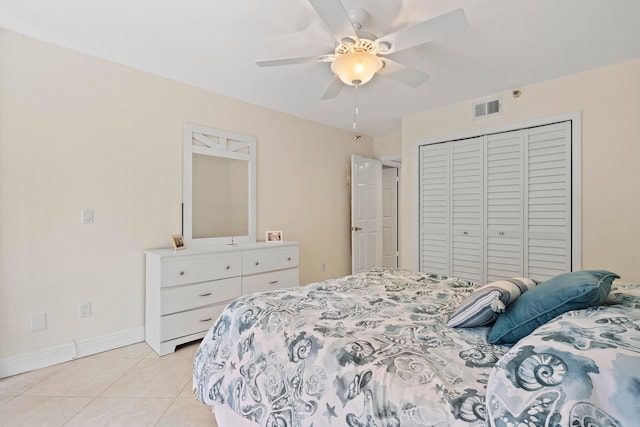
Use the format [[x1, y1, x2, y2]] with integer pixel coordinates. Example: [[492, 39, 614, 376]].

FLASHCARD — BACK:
[[0, 31, 373, 360]]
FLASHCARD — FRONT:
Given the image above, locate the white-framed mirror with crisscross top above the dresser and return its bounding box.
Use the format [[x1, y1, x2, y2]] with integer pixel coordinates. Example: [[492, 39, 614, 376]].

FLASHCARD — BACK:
[[183, 124, 256, 246]]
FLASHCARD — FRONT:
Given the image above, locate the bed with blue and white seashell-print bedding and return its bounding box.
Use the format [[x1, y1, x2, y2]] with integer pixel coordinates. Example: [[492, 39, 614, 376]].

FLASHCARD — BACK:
[[193, 269, 640, 427]]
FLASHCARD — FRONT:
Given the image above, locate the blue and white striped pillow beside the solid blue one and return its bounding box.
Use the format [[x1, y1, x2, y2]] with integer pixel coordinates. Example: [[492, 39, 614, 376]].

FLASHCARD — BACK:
[[447, 277, 539, 328]]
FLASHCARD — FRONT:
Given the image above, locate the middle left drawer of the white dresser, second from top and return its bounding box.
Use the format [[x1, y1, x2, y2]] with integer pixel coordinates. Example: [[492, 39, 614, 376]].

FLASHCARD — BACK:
[[160, 277, 242, 315]]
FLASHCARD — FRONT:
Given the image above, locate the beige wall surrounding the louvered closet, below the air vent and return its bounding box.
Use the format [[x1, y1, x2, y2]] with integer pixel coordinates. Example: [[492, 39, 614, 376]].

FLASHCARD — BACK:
[[401, 60, 640, 282]]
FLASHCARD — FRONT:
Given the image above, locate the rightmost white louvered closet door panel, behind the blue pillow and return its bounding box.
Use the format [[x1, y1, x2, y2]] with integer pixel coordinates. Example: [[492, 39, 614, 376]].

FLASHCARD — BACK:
[[525, 122, 571, 280]]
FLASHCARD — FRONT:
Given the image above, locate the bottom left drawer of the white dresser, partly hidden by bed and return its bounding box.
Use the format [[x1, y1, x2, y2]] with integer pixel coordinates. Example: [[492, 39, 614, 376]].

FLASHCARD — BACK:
[[160, 304, 226, 341]]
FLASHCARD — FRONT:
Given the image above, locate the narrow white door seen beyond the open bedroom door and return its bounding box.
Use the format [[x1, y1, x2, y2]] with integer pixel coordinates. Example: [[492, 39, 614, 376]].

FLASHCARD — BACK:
[[382, 166, 398, 268]]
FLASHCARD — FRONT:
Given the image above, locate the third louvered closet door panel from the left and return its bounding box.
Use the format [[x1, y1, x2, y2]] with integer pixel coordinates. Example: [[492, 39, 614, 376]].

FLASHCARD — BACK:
[[485, 131, 524, 282]]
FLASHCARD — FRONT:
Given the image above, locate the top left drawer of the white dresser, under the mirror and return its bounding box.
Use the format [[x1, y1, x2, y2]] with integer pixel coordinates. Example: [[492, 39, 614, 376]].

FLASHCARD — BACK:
[[161, 254, 242, 287]]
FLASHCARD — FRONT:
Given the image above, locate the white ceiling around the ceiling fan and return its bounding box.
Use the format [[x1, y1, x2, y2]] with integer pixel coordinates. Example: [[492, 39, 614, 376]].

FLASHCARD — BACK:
[[0, 0, 640, 137]]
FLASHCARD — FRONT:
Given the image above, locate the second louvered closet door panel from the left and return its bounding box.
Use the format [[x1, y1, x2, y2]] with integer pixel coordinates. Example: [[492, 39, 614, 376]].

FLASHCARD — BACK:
[[448, 137, 484, 282]]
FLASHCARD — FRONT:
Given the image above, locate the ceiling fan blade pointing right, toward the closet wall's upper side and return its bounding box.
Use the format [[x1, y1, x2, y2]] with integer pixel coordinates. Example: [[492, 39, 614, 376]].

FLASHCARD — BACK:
[[375, 9, 469, 55]]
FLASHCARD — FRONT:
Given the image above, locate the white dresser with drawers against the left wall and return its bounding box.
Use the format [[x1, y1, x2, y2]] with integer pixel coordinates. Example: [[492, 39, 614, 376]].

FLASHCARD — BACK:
[[145, 242, 299, 356]]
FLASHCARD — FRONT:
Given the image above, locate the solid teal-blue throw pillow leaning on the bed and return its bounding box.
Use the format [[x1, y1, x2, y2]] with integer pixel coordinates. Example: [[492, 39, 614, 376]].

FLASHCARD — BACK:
[[489, 270, 620, 344]]
